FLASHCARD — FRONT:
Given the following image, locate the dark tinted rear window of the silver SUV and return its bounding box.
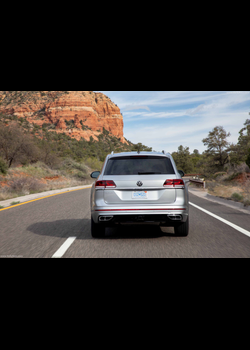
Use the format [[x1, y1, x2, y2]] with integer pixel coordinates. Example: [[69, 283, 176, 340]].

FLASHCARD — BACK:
[[104, 156, 175, 175]]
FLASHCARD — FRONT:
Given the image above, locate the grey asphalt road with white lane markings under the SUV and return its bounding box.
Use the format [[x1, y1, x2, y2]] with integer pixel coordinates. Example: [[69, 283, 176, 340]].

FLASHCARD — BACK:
[[0, 189, 250, 258]]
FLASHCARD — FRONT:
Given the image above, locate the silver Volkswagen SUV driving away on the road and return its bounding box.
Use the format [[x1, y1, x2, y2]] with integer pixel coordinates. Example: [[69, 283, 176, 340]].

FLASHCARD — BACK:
[[91, 151, 189, 238]]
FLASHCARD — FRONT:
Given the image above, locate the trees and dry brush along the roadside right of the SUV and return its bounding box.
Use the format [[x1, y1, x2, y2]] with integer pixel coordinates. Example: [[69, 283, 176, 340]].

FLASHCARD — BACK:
[[172, 119, 250, 206]]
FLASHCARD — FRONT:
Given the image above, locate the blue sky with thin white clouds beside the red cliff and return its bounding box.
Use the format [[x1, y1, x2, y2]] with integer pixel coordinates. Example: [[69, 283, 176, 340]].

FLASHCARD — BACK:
[[96, 91, 250, 153]]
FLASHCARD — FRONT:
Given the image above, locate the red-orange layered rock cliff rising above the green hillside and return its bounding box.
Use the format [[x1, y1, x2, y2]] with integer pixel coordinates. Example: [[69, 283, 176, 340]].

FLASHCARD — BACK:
[[0, 91, 126, 143]]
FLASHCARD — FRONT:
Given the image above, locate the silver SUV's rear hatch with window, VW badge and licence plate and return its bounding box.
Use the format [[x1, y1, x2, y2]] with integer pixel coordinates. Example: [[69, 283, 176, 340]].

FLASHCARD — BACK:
[[103, 155, 177, 206]]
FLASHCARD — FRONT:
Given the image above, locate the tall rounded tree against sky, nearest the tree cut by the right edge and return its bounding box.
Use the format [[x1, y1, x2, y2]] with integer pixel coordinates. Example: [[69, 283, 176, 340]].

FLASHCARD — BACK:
[[202, 126, 231, 166]]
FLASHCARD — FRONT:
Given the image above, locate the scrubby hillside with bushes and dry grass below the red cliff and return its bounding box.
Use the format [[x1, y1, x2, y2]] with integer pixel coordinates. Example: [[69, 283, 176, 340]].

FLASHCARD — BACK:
[[0, 114, 152, 201]]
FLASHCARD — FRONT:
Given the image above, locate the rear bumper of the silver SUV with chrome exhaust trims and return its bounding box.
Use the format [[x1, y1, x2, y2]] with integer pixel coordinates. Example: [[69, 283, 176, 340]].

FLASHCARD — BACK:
[[92, 206, 189, 226]]
